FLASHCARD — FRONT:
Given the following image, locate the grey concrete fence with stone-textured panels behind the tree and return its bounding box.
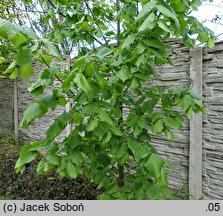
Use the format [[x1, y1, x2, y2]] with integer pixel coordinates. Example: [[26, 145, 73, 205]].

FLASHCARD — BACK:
[[0, 40, 223, 199]]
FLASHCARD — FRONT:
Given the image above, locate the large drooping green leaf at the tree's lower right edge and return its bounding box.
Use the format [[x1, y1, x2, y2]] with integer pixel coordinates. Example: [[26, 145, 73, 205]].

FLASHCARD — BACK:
[[145, 154, 164, 179]]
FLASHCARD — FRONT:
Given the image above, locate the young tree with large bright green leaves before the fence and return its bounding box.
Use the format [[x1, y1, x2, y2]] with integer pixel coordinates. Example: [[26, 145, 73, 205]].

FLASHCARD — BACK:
[[0, 0, 214, 199]]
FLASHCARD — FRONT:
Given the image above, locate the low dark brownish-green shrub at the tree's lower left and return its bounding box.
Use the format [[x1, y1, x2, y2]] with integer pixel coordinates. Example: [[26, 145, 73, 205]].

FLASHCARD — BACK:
[[0, 139, 98, 200]]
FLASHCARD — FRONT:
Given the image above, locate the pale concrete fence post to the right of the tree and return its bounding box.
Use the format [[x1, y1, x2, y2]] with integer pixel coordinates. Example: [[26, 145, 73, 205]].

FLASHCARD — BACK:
[[189, 47, 202, 200]]
